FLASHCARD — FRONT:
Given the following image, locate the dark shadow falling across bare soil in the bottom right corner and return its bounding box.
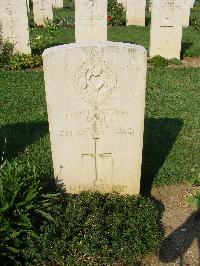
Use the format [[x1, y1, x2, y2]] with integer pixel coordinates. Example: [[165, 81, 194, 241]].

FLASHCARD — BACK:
[[159, 211, 200, 266]]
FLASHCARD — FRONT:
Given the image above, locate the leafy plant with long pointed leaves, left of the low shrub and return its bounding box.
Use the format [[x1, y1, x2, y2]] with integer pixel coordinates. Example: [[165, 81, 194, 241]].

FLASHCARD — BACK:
[[0, 162, 58, 265]]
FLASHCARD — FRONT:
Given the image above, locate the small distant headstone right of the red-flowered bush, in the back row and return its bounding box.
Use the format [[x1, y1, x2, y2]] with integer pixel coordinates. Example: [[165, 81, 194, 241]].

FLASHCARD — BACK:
[[126, 0, 146, 26]]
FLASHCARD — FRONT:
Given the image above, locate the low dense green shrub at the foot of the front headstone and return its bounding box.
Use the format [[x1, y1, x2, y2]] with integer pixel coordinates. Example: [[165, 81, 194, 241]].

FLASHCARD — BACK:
[[23, 192, 161, 265]]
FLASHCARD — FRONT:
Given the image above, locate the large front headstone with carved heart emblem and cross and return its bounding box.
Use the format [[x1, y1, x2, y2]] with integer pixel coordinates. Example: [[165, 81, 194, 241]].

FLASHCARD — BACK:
[[43, 42, 147, 194]]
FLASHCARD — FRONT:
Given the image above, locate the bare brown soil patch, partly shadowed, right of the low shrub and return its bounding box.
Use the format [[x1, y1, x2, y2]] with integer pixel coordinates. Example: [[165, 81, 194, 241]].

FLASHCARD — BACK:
[[141, 184, 200, 266]]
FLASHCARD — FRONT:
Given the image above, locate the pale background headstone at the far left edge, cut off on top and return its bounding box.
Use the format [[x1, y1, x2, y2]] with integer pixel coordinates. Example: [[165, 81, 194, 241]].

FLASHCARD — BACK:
[[0, 0, 31, 54]]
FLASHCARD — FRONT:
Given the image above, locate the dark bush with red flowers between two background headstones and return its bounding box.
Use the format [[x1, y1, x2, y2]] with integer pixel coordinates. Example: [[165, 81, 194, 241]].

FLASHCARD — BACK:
[[108, 0, 126, 26]]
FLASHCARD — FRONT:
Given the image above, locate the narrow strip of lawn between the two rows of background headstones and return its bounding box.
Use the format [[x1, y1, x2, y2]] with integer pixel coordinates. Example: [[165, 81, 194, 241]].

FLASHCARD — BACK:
[[31, 26, 200, 57]]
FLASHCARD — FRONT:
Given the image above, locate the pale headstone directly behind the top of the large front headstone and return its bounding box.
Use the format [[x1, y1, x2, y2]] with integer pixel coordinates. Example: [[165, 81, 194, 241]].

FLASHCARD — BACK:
[[75, 0, 107, 42]]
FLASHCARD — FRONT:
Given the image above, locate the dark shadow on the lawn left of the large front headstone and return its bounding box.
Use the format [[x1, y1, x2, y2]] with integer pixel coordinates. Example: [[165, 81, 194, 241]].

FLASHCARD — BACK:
[[0, 122, 48, 160]]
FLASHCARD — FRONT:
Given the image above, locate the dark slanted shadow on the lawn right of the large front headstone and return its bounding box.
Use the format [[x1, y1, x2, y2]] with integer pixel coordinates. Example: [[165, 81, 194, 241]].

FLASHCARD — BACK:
[[140, 118, 183, 196]]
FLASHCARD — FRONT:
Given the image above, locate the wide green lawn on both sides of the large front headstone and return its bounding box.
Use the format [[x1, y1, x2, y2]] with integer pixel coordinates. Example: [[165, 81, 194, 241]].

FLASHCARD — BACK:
[[0, 68, 200, 192]]
